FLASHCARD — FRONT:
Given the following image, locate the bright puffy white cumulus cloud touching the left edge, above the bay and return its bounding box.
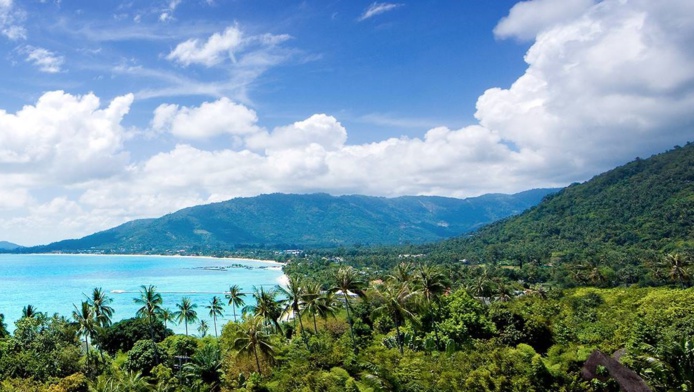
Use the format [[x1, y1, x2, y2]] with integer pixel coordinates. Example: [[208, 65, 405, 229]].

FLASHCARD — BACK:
[[0, 91, 133, 186]]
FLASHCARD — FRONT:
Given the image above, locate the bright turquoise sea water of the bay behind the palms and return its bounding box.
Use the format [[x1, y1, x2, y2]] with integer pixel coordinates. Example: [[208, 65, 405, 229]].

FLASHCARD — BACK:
[[0, 255, 283, 335]]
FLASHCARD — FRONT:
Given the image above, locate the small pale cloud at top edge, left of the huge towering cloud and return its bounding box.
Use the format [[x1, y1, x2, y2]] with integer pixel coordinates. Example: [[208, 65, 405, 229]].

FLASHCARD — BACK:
[[494, 0, 596, 40]]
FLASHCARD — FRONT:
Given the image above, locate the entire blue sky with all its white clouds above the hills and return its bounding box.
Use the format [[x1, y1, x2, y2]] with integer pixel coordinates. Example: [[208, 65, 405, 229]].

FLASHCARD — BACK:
[[0, 0, 694, 245]]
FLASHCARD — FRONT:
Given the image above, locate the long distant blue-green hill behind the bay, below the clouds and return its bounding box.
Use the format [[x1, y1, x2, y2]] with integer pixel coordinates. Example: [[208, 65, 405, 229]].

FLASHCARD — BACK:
[[22, 189, 557, 253]]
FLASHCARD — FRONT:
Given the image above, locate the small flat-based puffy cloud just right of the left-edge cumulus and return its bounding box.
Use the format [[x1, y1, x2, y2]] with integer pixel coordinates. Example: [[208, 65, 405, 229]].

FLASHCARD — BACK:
[[151, 98, 258, 139]]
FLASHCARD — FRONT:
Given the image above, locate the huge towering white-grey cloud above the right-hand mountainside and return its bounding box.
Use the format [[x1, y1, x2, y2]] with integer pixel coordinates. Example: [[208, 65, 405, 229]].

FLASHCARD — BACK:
[[476, 0, 694, 181]]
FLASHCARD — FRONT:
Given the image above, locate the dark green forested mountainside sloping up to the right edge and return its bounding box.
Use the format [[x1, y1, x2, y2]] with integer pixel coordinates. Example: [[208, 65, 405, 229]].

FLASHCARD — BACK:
[[436, 143, 694, 264]]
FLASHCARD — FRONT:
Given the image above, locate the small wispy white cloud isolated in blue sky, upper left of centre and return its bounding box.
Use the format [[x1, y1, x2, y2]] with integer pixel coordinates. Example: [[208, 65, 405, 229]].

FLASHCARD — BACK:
[[166, 26, 291, 67]]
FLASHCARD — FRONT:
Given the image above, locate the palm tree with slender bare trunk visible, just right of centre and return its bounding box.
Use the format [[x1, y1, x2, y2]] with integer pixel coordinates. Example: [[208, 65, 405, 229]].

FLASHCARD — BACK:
[[374, 279, 419, 355]]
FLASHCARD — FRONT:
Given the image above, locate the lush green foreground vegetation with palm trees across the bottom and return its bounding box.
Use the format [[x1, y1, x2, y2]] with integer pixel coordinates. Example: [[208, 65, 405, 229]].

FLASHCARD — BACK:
[[0, 263, 694, 391]]
